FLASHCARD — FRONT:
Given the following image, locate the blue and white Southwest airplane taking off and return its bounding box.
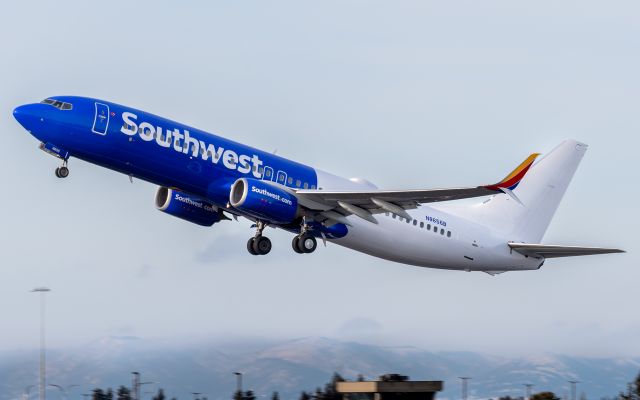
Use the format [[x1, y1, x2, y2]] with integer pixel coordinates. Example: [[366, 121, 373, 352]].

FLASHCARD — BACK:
[[13, 96, 624, 275]]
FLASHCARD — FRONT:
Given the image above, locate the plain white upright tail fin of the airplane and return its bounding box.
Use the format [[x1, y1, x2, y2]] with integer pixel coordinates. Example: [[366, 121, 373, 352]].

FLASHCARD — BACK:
[[452, 140, 588, 243]]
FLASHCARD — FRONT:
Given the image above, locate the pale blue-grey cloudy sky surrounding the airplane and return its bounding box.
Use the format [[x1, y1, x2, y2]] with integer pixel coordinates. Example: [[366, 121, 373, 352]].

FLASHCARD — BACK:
[[0, 0, 640, 357]]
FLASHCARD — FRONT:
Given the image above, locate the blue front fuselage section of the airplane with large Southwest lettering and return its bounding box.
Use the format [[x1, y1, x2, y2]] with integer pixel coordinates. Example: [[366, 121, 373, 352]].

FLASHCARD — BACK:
[[14, 96, 318, 207]]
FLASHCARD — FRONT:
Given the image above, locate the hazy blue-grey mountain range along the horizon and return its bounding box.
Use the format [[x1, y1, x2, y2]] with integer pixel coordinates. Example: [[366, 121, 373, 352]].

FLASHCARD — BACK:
[[0, 337, 640, 400]]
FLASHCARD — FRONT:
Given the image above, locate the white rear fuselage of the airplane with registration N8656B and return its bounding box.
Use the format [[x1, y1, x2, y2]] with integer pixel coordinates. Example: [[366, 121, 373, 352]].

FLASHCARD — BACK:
[[316, 170, 544, 273]]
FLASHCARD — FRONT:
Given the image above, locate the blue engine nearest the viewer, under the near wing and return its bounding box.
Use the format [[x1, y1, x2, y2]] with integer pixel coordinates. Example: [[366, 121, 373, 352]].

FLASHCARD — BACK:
[[229, 178, 298, 224]]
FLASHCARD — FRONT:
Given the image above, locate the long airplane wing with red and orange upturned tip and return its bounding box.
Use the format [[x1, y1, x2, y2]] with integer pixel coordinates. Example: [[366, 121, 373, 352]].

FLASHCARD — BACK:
[[295, 153, 539, 224]]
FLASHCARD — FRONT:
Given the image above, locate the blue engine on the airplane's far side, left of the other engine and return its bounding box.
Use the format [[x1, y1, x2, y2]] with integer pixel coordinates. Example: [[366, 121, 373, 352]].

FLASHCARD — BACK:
[[155, 186, 222, 226]]
